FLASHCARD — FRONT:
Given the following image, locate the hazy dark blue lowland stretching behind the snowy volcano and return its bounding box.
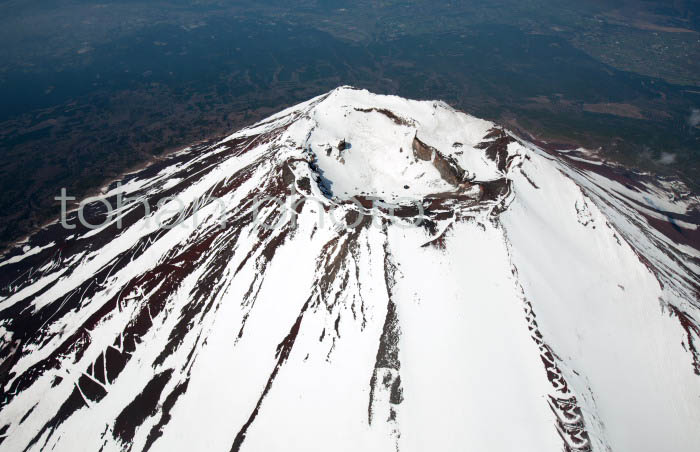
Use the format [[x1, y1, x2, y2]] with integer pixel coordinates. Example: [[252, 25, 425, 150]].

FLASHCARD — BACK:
[[0, 0, 700, 247]]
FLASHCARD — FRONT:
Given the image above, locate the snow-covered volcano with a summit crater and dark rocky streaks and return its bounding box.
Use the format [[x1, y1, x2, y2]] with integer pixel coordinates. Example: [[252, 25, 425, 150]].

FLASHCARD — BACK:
[[0, 87, 700, 452]]
